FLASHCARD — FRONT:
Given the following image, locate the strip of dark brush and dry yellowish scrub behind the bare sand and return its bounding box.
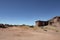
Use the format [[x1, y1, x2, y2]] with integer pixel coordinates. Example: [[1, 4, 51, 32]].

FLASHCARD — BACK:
[[0, 24, 59, 32]]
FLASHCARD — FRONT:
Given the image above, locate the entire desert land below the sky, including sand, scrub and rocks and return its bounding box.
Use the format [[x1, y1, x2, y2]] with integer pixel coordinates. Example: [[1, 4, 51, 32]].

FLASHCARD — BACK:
[[0, 17, 60, 40]]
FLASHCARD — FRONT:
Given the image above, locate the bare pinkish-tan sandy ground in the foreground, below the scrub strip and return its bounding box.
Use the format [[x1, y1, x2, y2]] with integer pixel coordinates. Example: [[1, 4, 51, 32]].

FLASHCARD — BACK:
[[0, 27, 60, 40]]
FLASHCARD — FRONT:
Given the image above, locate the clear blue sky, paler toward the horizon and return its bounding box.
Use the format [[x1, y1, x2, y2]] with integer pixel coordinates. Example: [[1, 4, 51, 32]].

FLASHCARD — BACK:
[[0, 0, 60, 25]]
